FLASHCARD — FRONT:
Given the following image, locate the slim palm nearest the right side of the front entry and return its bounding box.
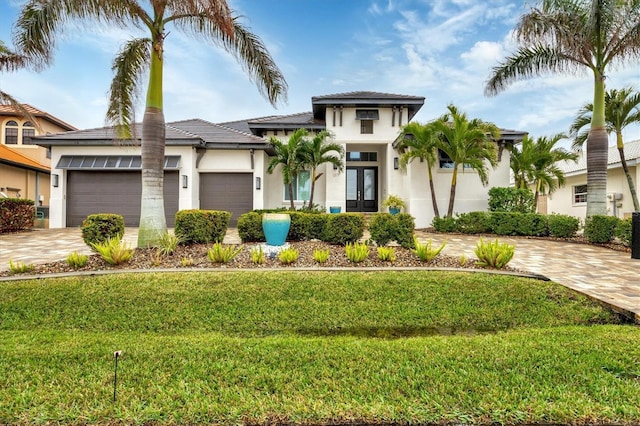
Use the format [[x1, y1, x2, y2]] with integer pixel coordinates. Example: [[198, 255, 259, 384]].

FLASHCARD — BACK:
[[398, 121, 440, 218]]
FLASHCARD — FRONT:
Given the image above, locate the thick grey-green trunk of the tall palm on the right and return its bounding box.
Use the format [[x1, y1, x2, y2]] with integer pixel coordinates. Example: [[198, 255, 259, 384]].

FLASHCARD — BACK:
[[587, 75, 609, 217]]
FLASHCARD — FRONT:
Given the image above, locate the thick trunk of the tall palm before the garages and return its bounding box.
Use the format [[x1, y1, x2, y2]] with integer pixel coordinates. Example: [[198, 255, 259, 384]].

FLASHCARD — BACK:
[[138, 41, 167, 247]]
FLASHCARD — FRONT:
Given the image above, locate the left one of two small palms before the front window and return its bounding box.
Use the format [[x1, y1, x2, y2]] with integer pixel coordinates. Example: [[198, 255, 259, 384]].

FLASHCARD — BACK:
[[267, 129, 308, 210]]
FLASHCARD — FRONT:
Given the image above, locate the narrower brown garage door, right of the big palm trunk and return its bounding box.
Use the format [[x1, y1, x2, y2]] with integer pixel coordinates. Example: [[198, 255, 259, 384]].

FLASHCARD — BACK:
[[200, 173, 253, 226]]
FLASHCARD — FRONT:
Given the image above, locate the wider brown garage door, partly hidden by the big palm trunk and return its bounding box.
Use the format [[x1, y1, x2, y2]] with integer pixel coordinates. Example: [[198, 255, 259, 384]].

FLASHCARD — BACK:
[[67, 170, 179, 227]]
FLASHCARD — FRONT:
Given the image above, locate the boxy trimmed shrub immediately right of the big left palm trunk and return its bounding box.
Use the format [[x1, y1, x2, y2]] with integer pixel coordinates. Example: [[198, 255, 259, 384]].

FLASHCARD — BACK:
[[175, 209, 231, 244]]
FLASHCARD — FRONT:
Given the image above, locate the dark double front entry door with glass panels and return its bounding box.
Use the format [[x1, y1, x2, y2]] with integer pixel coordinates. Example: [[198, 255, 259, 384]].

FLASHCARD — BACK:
[[347, 167, 378, 212]]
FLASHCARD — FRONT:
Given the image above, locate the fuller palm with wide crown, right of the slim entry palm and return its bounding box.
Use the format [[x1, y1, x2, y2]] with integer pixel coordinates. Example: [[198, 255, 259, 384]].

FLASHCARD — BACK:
[[432, 105, 500, 217]]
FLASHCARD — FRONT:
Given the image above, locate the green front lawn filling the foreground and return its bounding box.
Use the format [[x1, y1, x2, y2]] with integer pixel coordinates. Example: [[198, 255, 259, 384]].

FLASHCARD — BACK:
[[0, 271, 640, 424]]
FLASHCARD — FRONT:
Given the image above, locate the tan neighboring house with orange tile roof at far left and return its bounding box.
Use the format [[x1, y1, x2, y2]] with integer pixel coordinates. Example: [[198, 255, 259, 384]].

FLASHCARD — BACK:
[[0, 104, 76, 210]]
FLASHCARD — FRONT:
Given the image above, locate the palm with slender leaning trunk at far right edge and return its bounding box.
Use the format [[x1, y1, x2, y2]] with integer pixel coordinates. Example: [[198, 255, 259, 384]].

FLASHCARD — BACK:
[[570, 87, 640, 211]]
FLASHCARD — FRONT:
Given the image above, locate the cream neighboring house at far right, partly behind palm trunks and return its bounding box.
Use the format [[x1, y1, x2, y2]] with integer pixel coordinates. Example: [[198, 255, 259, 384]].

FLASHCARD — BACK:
[[543, 140, 640, 219]]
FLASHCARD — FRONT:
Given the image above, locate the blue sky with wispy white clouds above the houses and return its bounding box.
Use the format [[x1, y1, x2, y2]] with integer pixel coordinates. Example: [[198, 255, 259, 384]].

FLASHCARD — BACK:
[[0, 0, 640, 146]]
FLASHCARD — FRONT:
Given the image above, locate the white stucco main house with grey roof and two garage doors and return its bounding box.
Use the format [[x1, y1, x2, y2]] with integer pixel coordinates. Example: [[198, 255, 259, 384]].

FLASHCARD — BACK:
[[37, 92, 524, 227]]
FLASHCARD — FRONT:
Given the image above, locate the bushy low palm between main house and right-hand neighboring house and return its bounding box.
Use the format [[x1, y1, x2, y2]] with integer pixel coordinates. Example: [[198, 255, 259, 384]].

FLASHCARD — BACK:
[[511, 133, 578, 209]]
